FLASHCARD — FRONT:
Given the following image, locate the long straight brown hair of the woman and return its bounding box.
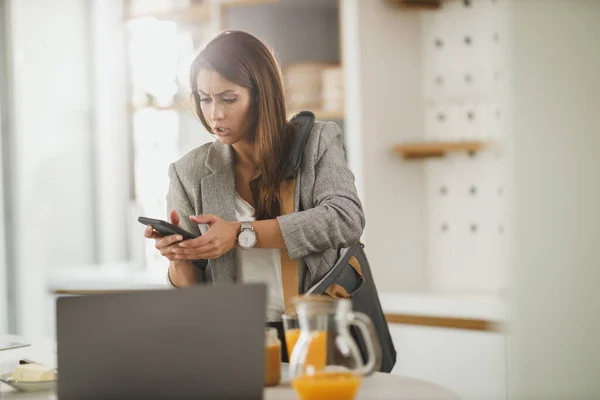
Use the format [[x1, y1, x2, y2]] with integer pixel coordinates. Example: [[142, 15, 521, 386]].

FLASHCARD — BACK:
[[190, 31, 294, 220]]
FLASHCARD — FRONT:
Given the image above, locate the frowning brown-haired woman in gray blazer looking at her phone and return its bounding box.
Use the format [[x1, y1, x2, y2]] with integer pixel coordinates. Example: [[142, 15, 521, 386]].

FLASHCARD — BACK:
[[145, 31, 365, 357]]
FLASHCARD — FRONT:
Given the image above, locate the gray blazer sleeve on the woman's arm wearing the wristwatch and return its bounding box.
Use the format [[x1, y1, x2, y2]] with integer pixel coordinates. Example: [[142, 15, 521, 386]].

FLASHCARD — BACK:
[[277, 123, 365, 259]]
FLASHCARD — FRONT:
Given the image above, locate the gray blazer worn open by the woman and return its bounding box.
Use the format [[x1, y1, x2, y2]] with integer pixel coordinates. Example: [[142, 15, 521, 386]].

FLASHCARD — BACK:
[[167, 118, 365, 293]]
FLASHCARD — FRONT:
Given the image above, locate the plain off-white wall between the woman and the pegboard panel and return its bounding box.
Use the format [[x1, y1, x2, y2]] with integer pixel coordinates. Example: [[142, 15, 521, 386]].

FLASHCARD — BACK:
[[341, 0, 427, 291]]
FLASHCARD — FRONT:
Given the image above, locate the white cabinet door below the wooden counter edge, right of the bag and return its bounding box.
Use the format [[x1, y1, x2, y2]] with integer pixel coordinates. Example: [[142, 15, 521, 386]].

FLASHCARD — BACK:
[[390, 324, 507, 400]]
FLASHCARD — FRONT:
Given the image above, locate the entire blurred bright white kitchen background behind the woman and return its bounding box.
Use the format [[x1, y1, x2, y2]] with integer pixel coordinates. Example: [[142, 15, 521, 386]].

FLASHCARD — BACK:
[[0, 0, 600, 399]]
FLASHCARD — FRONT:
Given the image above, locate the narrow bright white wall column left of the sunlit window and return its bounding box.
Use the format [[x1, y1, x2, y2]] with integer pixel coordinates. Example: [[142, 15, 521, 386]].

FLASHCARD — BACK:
[[86, 0, 132, 263]]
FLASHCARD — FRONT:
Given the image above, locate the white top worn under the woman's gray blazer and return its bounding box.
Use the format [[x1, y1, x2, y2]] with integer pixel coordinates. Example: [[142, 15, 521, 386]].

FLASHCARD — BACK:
[[235, 193, 285, 322]]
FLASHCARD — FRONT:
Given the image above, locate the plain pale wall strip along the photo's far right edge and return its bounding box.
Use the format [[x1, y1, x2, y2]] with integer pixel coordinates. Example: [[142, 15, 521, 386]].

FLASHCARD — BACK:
[[509, 0, 600, 400]]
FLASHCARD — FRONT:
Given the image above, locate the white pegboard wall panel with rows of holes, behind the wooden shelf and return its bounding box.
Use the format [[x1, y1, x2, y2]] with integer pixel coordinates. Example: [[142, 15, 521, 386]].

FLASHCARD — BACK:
[[413, 0, 512, 294]]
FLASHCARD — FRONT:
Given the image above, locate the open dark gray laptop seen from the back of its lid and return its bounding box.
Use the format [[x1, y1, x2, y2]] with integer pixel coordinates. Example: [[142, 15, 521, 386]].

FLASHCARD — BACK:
[[56, 284, 266, 400]]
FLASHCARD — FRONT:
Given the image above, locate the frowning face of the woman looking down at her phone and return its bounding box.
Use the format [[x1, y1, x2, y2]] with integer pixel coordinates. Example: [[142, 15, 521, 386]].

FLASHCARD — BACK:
[[196, 69, 253, 144]]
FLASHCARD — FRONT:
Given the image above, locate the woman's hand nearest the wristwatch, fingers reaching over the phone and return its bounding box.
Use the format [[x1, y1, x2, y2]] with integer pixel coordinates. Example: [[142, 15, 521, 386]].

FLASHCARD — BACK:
[[173, 215, 240, 260]]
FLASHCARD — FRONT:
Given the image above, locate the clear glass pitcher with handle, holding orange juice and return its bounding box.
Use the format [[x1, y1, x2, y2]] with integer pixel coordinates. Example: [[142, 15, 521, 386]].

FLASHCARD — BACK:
[[286, 295, 381, 400]]
